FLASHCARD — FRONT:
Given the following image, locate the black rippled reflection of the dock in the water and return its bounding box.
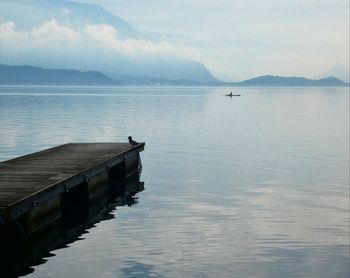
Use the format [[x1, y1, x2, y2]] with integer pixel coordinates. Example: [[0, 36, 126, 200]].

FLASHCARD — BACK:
[[0, 177, 144, 277]]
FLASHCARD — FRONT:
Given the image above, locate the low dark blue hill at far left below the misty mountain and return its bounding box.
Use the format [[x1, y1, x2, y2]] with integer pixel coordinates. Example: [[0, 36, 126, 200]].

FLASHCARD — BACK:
[[0, 65, 116, 85]]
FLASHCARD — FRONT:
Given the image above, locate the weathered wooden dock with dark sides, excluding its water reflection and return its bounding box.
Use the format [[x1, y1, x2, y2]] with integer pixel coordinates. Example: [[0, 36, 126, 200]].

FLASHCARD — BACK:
[[0, 143, 145, 234]]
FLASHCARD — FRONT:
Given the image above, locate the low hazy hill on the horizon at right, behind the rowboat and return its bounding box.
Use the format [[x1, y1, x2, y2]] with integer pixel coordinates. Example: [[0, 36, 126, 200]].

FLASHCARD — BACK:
[[232, 75, 349, 87]]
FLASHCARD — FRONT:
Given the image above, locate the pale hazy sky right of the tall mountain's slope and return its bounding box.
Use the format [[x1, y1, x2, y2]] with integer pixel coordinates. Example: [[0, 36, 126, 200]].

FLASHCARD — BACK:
[[75, 0, 349, 81]]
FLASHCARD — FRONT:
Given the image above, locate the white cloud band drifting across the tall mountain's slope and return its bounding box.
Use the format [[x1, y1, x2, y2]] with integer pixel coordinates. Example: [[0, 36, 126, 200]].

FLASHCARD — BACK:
[[0, 20, 195, 63]]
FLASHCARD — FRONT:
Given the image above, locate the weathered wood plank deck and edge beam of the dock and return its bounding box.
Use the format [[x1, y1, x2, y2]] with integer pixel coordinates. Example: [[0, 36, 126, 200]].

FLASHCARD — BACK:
[[0, 143, 145, 223]]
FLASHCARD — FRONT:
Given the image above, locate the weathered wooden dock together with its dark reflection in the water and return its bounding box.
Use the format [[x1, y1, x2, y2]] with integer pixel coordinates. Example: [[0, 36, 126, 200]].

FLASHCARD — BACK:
[[0, 143, 145, 277]]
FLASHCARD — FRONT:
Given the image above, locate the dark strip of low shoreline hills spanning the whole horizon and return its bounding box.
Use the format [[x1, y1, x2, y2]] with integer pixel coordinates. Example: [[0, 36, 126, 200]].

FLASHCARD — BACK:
[[0, 64, 349, 87]]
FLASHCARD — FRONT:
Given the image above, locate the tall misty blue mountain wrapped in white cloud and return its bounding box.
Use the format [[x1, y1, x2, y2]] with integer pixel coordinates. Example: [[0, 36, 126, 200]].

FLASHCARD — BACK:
[[0, 0, 217, 83]]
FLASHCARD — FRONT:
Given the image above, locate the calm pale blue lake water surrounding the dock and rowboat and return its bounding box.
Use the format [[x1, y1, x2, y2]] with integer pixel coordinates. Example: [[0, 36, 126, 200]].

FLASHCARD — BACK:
[[0, 87, 350, 277]]
